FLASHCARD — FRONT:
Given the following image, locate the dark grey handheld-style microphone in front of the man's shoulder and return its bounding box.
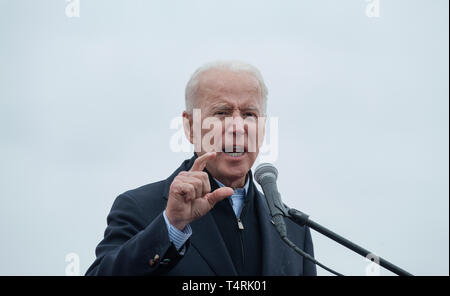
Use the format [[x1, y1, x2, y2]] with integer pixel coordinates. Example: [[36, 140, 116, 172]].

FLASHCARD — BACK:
[[255, 163, 288, 238]]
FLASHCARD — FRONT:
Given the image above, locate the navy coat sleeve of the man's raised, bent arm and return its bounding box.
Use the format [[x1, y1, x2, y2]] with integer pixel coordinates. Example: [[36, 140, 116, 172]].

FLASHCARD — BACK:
[[86, 194, 182, 276]]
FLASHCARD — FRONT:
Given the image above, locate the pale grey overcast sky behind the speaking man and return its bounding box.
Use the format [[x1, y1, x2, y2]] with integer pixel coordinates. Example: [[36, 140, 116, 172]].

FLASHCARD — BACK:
[[0, 0, 449, 275]]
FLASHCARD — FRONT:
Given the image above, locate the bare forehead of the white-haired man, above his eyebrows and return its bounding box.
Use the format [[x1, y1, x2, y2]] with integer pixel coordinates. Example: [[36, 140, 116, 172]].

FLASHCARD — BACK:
[[197, 69, 262, 107]]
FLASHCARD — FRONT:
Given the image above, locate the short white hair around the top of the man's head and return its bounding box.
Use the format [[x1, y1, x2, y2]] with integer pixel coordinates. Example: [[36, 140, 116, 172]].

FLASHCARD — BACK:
[[185, 61, 268, 114]]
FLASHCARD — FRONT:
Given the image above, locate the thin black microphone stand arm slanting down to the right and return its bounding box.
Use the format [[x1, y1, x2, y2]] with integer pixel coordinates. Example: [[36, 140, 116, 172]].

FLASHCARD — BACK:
[[287, 209, 412, 276]]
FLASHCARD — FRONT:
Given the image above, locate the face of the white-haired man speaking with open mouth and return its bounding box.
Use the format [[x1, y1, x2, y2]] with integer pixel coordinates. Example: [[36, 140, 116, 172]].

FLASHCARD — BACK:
[[183, 69, 264, 187]]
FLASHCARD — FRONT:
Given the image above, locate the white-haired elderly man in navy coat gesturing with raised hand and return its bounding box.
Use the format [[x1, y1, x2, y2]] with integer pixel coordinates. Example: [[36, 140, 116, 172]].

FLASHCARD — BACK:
[[86, 62, 316, 275]]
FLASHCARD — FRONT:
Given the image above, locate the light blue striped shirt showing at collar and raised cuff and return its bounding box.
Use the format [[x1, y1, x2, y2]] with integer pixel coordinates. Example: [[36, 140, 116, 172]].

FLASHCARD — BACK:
[[163, 178, 250, 255]]
